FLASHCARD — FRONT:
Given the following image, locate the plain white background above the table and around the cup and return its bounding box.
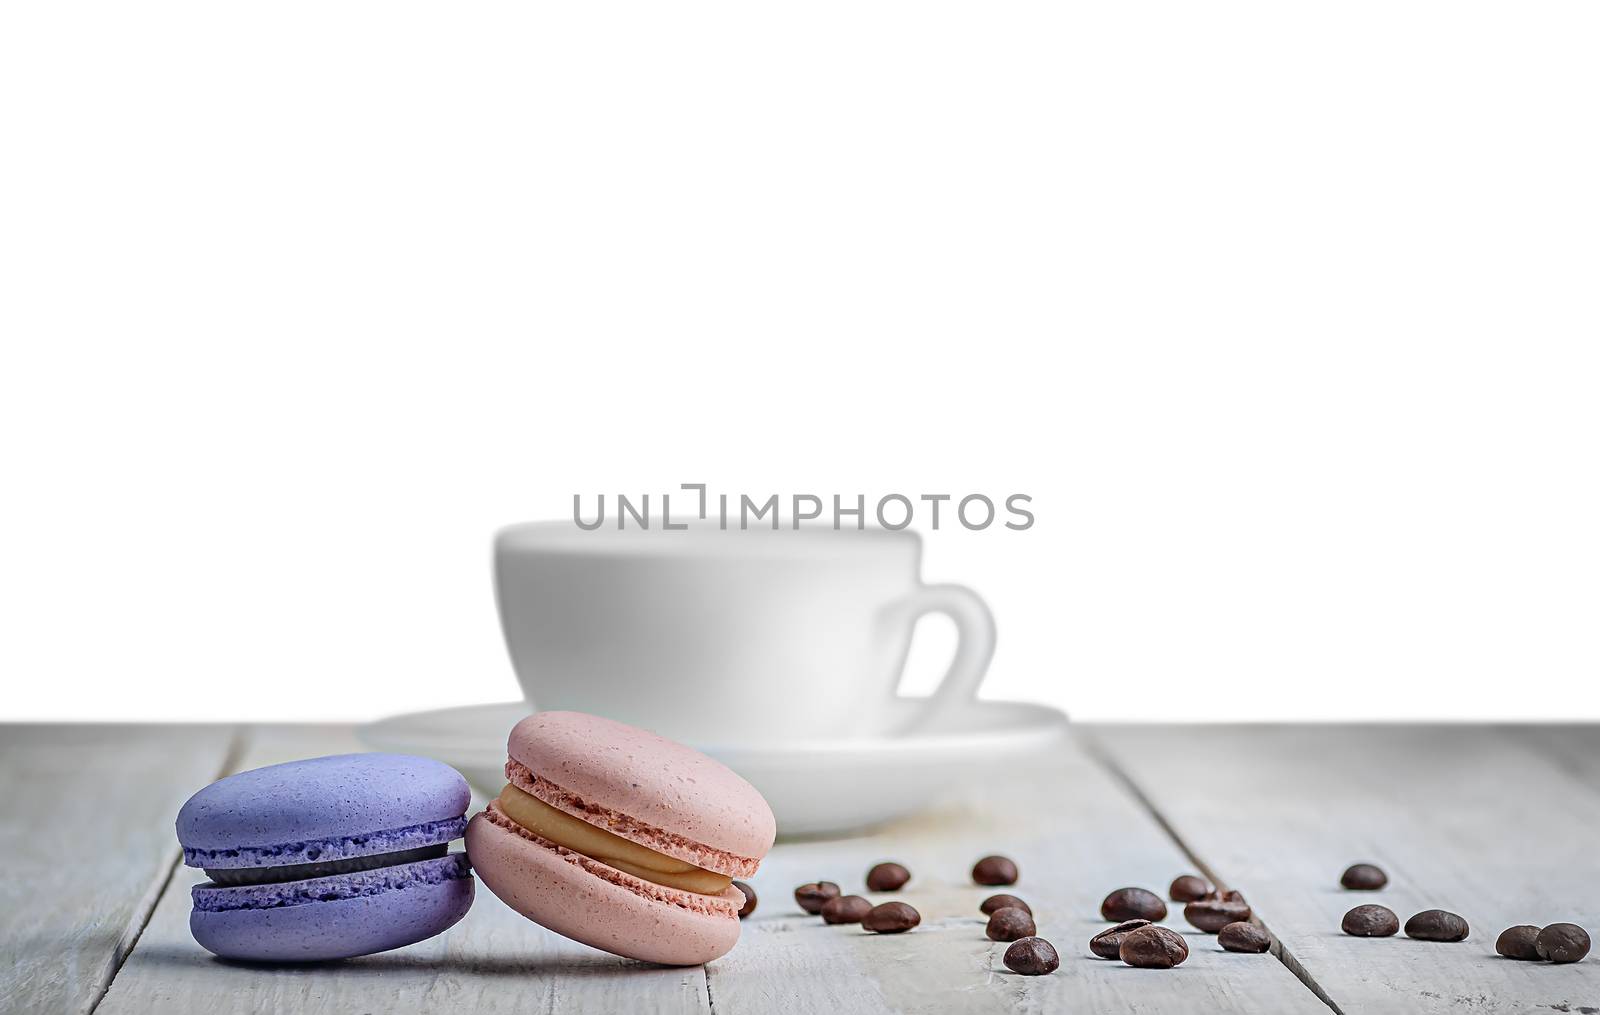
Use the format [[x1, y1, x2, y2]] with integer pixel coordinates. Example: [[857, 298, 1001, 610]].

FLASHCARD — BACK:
[[0, 0, 1600, 719]]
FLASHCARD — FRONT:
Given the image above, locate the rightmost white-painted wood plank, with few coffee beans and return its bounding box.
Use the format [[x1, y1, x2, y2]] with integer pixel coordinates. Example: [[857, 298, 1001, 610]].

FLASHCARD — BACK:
[[1094, 725, 1600, 1015]]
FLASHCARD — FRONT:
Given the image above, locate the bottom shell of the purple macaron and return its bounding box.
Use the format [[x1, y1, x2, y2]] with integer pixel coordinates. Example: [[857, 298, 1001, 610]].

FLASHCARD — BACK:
[[189, 876, 475, 962]]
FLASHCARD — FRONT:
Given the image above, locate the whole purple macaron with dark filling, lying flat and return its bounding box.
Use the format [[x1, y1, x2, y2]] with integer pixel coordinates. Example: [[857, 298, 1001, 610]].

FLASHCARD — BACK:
[[178, 754, 474, 962]]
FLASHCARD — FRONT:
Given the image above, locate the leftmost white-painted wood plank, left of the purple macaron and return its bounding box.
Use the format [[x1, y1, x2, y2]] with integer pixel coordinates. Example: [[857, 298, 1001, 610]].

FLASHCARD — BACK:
[[0, 725, 234, 1012]]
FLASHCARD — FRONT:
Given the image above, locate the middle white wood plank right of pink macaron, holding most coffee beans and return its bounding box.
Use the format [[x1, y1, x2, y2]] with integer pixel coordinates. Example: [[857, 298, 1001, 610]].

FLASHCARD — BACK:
[[707, 730, 1328, 1015]]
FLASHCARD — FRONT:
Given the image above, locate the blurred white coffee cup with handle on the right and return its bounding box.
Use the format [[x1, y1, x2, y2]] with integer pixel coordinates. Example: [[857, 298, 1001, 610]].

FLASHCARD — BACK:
[[494, 522, 995, 746]]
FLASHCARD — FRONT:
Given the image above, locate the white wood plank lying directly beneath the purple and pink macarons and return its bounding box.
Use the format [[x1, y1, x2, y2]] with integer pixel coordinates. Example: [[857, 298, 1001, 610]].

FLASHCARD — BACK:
[[98, 727, 709, 1015]]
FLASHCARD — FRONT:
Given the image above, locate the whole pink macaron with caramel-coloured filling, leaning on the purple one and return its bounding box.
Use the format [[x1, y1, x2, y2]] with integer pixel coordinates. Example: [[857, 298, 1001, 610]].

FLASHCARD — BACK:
[[467, 712, 778, 965]]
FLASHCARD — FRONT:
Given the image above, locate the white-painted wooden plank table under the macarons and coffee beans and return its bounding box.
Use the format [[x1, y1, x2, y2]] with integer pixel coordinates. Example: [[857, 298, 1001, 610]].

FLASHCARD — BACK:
[[0, 725, 1600, 1015]]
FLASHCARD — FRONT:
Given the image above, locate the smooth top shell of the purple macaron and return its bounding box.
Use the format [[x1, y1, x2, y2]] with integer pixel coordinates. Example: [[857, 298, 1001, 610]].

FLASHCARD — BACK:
[[178, 754, 472, 866]]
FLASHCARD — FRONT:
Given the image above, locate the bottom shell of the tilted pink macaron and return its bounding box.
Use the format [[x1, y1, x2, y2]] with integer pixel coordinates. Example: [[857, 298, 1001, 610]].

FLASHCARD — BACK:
[[467, 803, 744, 965]]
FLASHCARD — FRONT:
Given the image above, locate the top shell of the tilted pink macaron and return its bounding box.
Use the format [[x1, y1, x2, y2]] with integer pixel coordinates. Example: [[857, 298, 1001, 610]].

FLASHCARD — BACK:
[[507, 712, 778, 860]]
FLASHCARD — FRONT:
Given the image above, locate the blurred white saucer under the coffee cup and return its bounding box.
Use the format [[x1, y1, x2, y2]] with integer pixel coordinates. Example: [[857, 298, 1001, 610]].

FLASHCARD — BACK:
[[360, 701, 1067, 836]]
